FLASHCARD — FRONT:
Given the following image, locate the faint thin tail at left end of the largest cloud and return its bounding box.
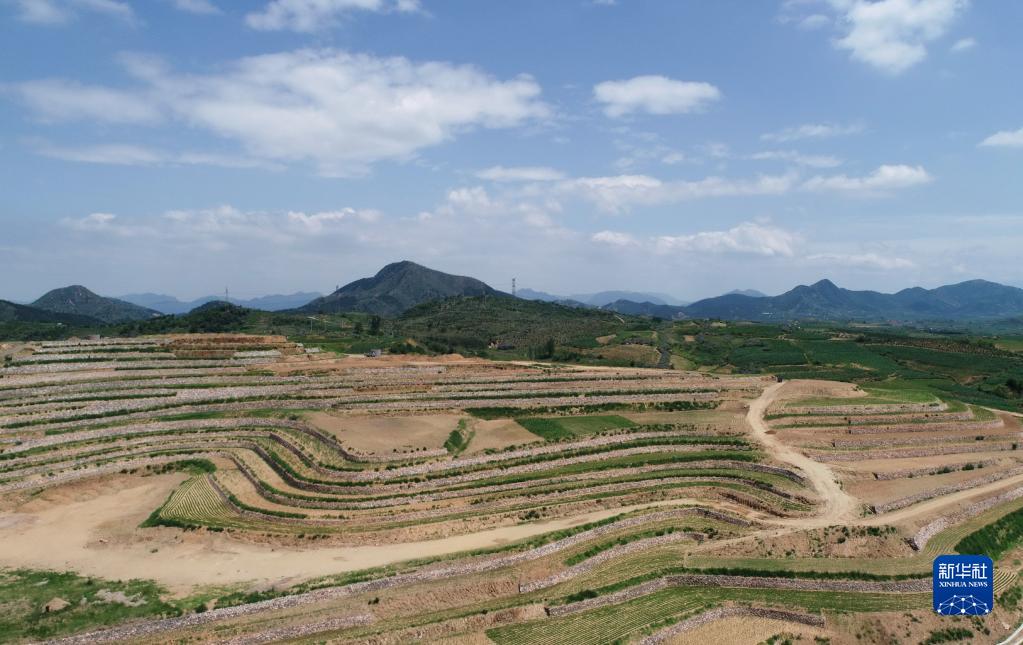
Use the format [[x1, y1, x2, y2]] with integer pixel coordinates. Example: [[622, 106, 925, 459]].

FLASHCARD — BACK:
[[12, 79, 162, 124]]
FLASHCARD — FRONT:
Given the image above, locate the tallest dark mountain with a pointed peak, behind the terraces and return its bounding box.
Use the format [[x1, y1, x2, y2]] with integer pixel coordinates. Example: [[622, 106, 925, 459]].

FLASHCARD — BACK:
[[296, 260, 512, 316]]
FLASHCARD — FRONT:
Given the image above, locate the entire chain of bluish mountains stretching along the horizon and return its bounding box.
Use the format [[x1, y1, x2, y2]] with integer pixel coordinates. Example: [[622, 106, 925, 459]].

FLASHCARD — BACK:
[[7, 261, 1023, 326]]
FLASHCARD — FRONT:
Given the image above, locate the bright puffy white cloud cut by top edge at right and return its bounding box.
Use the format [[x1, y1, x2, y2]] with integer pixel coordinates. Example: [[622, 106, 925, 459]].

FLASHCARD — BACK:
[[830, 0, 969, 75]]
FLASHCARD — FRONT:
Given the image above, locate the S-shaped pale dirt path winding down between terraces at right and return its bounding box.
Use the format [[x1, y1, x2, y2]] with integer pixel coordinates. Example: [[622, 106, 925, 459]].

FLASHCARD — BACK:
[[746, 383, 859, 528]]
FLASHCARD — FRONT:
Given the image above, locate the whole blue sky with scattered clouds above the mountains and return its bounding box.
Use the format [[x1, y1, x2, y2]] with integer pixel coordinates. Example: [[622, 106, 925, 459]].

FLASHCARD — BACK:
[[0, 0, 1023, 300]]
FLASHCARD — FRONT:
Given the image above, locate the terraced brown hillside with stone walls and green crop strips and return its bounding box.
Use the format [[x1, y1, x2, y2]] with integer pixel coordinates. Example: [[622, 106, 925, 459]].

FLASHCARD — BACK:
[[6, 335, 1023, 643]]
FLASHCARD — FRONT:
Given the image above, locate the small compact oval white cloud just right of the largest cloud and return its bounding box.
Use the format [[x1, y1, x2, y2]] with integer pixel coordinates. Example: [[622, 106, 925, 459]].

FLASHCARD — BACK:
[[593, 76, 721, 118]]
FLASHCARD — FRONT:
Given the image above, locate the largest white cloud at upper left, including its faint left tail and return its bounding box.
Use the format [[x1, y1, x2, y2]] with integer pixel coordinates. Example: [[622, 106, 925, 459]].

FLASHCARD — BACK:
[[9, 49, 548, 176]]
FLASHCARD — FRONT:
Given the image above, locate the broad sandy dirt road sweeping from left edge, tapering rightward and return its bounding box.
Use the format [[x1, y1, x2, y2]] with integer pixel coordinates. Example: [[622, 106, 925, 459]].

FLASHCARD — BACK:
[[0, 475, 716, 594]]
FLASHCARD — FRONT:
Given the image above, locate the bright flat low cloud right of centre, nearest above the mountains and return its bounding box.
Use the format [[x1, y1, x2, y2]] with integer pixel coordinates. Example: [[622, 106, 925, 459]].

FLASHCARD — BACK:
[[655, 222, 798, 257]]
